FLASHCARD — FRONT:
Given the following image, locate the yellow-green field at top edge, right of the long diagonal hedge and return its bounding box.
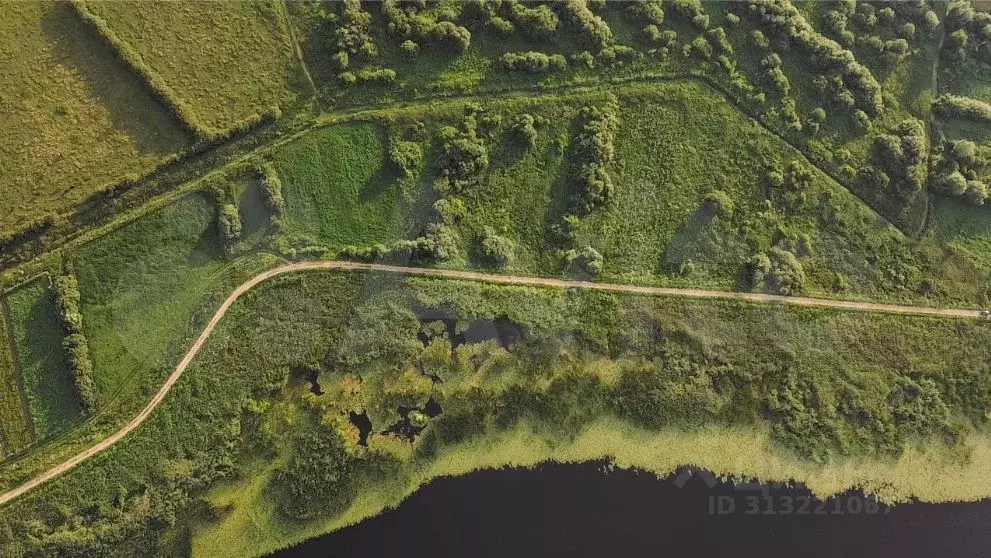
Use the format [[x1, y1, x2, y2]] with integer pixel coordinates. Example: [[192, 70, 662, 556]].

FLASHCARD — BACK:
[[86, 1, 305, 130]]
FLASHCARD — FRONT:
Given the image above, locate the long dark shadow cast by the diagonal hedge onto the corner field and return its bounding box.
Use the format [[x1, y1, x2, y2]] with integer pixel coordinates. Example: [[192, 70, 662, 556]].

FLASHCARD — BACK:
[[41, 2, 193, 156]]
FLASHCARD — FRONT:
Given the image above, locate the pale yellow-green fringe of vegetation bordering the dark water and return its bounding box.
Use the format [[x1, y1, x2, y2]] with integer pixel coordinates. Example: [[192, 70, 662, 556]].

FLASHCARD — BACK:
[[192, 418, 991, 556]]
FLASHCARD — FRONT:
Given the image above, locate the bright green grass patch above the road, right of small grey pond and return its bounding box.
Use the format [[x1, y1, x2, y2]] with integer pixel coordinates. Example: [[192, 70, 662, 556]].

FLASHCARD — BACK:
[[273, 124, 423, 249]]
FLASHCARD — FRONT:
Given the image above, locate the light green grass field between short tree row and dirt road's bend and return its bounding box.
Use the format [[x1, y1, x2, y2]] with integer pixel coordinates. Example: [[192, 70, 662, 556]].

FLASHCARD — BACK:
[[74, 194, 276, 396]]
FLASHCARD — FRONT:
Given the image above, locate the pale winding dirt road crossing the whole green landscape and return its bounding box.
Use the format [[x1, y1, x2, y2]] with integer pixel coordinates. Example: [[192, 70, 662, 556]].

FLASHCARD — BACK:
[[0, 261, 981, 506]]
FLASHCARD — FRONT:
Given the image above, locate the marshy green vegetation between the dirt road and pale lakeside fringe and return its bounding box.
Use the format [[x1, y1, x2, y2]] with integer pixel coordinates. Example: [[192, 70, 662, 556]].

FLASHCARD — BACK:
[[4, 273, 989, 554]]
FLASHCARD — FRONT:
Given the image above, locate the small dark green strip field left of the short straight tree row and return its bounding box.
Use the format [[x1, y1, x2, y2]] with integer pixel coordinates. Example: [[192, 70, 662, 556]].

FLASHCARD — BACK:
[[7, 280, 80, 440]]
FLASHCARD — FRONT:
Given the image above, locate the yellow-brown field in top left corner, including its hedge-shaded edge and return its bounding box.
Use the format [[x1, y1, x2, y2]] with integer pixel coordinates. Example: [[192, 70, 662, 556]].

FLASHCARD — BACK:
[[0, 1, 190, 231]]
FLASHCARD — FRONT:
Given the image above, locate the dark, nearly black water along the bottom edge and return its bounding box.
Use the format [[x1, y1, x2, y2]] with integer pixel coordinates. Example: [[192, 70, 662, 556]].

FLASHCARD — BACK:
[[277, 463, 991, 558]]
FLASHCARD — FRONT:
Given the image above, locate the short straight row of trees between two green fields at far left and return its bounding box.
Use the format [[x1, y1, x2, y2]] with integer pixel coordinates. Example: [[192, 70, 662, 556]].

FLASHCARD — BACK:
[[53, 275, 99, 414]]
